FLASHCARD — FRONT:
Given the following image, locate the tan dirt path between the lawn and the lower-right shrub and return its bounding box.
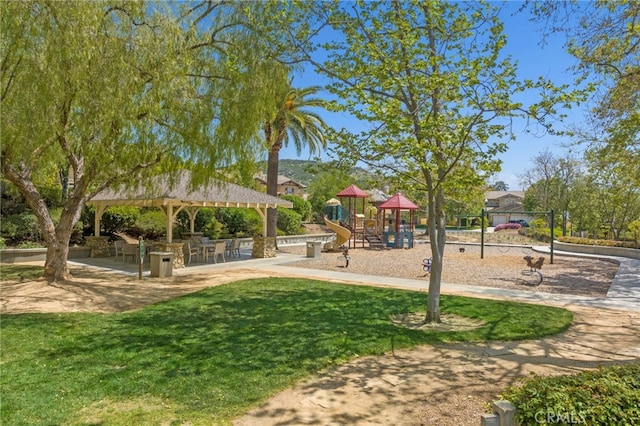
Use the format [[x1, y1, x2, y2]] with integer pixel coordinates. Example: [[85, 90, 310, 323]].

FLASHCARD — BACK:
[[234, 308, 640, 426]]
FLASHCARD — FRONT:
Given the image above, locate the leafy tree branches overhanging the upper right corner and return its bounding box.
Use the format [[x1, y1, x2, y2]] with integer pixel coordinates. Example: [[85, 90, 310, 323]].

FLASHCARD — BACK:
[[528, 0, 640, 187]]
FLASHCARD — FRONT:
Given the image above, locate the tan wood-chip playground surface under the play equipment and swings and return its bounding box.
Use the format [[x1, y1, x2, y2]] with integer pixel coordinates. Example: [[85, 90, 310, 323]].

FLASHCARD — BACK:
[[280, 242, 618, 298]]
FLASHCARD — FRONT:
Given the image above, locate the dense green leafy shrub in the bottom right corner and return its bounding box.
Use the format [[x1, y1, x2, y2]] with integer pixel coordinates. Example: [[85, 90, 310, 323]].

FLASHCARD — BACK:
[[501, 364, 640, 425]]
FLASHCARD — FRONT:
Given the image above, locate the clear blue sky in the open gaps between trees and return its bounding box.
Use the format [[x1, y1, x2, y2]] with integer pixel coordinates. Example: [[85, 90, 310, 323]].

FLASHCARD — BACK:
[[280, 2, 584, 190]]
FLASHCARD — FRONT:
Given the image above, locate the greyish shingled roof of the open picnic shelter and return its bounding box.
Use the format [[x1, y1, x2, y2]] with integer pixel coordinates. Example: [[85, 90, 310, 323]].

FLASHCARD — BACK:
[[88, 171, 293, 208]]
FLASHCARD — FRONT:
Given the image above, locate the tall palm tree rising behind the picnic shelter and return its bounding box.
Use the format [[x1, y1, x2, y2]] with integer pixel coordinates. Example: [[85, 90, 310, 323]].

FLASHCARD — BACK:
[[263, 85, 326, 241]]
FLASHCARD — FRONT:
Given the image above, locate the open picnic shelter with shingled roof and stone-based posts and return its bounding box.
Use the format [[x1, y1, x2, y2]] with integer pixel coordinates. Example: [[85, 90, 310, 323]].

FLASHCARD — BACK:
[[87, 170, 293, 266]]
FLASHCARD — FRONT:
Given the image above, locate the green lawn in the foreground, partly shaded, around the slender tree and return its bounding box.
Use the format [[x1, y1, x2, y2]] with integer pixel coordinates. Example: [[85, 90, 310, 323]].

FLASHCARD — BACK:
[[0, 278, 572, 425]]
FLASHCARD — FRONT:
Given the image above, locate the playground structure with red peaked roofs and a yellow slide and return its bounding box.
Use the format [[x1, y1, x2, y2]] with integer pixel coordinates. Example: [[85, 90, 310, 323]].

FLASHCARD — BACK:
[[324, 185, 418, 251]]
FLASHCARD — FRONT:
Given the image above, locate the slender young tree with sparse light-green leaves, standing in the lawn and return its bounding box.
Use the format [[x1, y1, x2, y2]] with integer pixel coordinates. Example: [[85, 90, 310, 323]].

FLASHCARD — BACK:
[[292, 1, 570, 322]]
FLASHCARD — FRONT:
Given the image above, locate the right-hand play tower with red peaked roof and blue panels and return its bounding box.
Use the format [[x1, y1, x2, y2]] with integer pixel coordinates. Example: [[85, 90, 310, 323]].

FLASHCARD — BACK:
[[378, 192, 419, 248]]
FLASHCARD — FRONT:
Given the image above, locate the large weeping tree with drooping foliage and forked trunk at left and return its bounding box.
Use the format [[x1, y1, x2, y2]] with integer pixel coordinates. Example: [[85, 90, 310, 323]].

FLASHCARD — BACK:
[[0, 1, 287, 281]]
